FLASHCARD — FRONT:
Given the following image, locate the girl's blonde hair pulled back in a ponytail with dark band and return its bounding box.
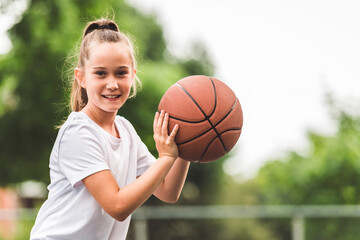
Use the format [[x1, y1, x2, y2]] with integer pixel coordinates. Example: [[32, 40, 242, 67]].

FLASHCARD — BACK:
[[70, 19, 141, 112]]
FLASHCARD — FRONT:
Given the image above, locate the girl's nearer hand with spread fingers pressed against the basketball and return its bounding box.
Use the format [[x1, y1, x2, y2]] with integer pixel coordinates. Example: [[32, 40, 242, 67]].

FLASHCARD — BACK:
[[153, 110, 179, 159]]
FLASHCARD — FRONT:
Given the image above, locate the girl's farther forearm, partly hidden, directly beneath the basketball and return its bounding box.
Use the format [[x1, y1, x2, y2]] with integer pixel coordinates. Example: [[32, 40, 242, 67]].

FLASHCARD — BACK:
[[154, 158, 190, 202]]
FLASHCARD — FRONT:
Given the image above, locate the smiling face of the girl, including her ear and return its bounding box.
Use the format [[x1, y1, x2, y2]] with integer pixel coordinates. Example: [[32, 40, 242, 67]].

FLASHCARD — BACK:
[[75, 42, 136, 114]]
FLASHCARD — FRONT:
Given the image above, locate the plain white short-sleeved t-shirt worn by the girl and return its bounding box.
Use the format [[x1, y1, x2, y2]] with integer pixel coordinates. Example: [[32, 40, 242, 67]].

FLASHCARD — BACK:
[[30, 112, 156, 240]]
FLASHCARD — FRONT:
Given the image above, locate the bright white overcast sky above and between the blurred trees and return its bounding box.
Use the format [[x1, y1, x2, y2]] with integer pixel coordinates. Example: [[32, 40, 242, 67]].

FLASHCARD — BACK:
[[0, 0, 360, 180]]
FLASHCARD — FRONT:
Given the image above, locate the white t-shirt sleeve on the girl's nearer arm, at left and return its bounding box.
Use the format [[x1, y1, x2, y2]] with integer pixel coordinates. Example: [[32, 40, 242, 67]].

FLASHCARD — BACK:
[[58, 124, 109, 187]]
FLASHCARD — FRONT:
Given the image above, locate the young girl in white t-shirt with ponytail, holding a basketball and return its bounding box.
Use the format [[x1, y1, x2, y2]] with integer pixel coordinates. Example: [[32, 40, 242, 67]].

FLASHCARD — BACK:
[[30, 17, 189, 240]]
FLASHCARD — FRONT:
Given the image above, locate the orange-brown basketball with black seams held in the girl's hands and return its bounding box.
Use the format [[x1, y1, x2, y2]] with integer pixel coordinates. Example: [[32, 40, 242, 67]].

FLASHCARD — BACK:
[[158, 75, 243, 163]]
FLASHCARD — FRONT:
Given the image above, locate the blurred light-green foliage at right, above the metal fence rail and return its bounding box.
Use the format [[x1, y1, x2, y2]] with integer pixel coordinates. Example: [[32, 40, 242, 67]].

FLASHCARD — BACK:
[[256, 102, 360, 204]]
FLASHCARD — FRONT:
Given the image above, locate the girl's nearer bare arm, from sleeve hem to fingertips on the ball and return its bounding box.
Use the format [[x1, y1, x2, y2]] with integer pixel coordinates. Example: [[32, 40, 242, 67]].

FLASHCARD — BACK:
[[83, 111, 181, 221]]
